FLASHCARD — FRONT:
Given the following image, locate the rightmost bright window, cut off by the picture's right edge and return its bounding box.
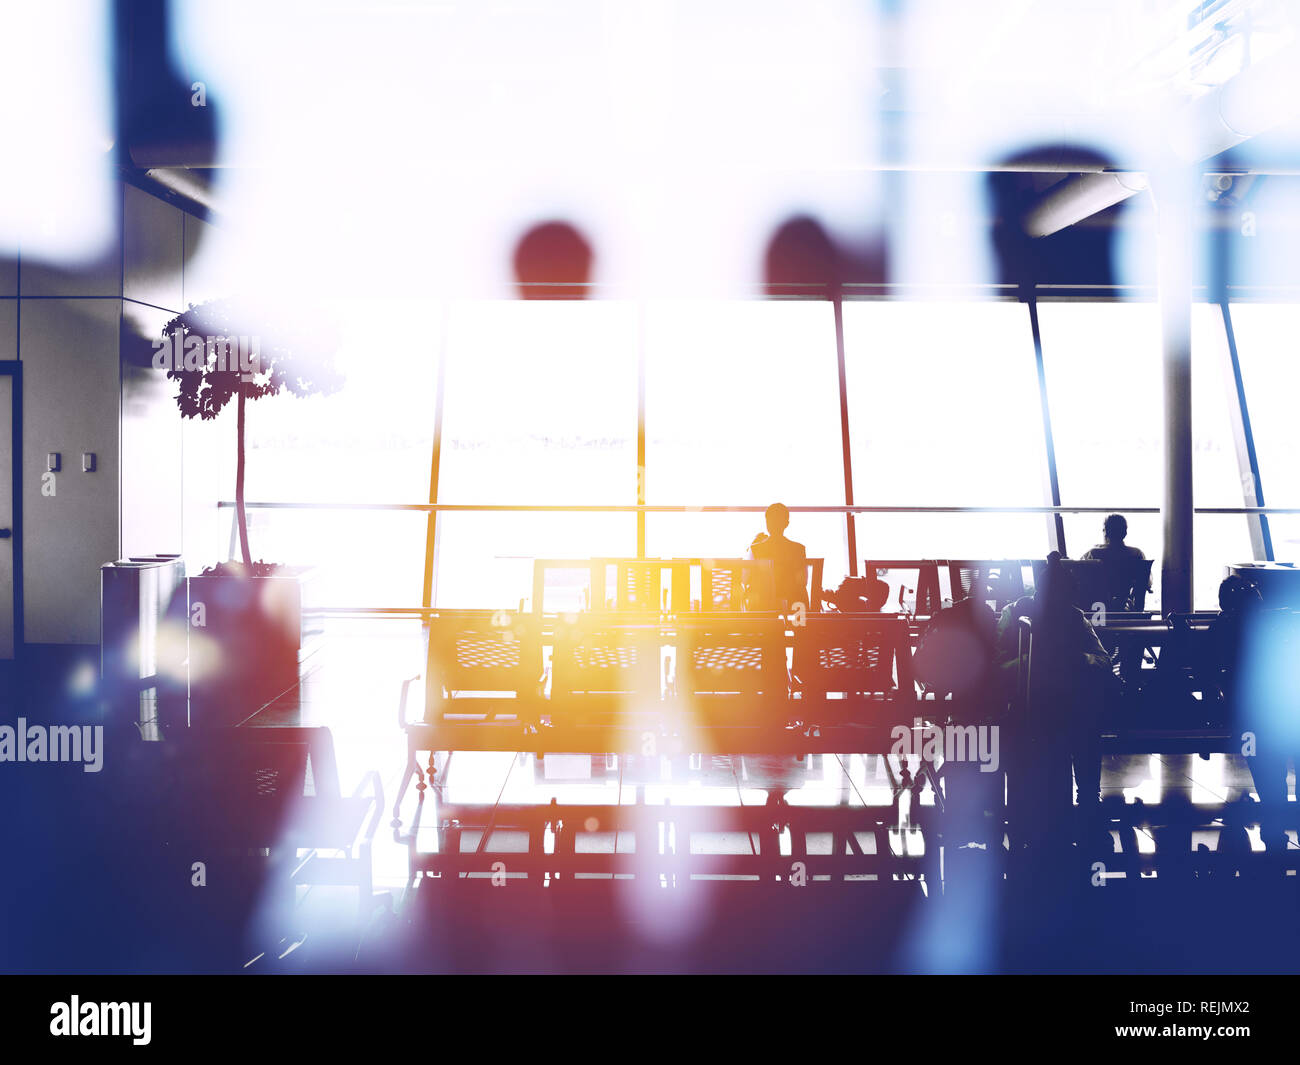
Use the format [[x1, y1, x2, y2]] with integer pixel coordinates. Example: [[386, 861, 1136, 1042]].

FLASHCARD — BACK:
[[1231, 303, 1300, 562]]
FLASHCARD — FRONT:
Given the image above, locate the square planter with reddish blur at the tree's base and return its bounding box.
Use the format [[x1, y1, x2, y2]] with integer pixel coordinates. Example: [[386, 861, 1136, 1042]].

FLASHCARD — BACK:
[[189, 567, 313, 727]]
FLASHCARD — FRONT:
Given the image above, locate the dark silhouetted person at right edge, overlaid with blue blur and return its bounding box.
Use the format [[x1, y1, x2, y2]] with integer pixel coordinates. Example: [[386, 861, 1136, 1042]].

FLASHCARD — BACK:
[[1210, 576, 1300, 849]]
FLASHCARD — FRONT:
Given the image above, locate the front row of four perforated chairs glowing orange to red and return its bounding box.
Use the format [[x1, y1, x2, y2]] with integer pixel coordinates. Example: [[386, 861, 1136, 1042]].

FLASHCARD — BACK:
[[413, 611, 915, 726]]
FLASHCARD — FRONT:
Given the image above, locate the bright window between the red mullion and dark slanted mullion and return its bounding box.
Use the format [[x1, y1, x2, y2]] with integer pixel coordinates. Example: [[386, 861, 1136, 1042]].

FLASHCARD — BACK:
[[844, 300, 1047, 558]]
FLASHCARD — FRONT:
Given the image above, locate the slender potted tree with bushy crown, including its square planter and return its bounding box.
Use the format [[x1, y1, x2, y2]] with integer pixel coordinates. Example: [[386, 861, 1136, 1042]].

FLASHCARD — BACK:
[[153, 299, 343, 724]]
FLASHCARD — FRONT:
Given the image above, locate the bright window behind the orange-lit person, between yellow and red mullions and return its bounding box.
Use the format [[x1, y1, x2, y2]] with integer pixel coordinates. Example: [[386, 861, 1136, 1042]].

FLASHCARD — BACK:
[[645, 300, 848, 583]]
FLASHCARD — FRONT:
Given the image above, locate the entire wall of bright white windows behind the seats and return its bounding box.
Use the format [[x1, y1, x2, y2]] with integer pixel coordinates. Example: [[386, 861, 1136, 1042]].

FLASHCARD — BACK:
[[208, 300, 1263, 606]]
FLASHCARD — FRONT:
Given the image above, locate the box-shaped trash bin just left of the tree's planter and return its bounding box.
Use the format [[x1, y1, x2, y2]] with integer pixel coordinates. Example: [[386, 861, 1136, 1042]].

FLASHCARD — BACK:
[[99, 555, 189, 740]]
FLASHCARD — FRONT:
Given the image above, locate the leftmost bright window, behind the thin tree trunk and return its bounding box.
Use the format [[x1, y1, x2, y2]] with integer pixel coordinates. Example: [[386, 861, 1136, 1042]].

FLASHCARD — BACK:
[[240, 299, 442, 606]]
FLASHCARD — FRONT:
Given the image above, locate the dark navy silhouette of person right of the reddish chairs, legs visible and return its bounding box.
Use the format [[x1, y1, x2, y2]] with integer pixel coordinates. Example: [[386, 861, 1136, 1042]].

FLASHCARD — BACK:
[[997, 551, 1119, 828]]
